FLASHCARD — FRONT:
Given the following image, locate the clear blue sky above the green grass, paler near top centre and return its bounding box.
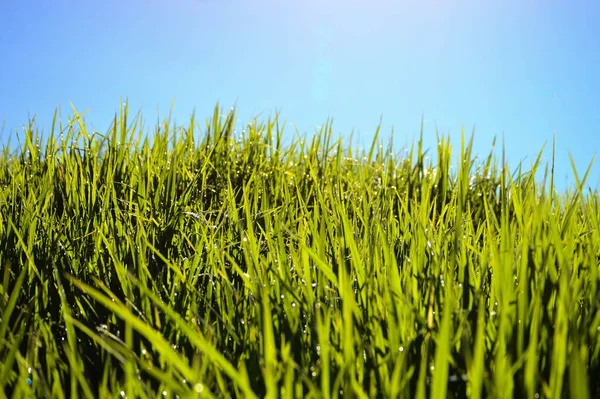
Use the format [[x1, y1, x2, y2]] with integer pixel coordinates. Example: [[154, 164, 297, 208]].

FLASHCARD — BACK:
[[0, 0, 600, 188]]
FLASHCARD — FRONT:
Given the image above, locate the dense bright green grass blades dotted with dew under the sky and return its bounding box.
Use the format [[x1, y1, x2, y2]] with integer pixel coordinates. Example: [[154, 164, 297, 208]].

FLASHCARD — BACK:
[[0, 106, 600, 399]]
